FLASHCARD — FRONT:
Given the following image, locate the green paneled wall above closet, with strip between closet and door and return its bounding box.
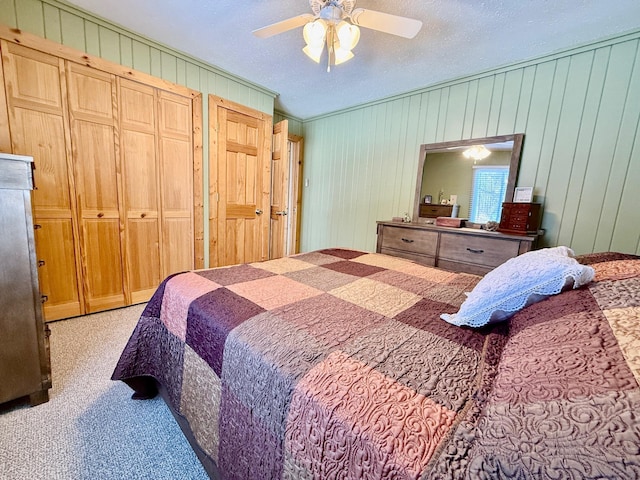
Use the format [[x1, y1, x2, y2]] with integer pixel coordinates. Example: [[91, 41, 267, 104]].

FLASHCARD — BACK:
[[0, 0, 276, 266]]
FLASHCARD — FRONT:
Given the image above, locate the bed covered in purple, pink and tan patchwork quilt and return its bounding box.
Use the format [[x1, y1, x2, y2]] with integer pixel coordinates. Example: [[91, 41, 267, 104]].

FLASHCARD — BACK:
[[112, 249, 640, 479]]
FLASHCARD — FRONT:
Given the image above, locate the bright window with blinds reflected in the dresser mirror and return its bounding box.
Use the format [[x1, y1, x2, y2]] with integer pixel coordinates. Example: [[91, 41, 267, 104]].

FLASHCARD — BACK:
[[469, 165, 509, 223]]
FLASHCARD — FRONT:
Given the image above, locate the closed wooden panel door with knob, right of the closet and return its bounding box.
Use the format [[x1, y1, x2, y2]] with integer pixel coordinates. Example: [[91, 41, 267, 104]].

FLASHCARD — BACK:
[[209, 95, 273, 267]]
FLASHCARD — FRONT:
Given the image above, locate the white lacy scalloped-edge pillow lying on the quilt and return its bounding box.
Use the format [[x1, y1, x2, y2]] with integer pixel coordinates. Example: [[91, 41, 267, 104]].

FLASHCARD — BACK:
[[440, 247, 595, 327]]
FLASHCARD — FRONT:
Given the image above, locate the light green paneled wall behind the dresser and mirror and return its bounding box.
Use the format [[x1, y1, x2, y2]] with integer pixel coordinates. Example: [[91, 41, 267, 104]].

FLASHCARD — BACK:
[[302, 31, 640, 254]]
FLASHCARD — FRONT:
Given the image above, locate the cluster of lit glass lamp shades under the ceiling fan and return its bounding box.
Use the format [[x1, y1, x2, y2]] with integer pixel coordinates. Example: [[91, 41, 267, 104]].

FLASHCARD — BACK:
[[302, 18, 360, 72]]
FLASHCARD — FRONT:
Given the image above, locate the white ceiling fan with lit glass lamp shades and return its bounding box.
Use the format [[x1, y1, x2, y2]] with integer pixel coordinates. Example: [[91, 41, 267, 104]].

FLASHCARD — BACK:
[[253, 0, 422, 71]]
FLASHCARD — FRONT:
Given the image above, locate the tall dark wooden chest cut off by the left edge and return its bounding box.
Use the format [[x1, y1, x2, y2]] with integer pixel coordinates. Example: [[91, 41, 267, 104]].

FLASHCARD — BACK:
[[0, 153, 51, 405]]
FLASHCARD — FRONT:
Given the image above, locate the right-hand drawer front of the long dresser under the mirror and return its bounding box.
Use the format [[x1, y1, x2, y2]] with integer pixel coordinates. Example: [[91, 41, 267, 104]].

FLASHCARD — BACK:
[[438, 233, 520, 267]]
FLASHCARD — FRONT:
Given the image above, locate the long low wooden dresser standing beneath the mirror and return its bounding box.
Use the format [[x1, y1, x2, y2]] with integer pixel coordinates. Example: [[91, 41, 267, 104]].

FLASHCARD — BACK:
[[376, 222, 537, 275]]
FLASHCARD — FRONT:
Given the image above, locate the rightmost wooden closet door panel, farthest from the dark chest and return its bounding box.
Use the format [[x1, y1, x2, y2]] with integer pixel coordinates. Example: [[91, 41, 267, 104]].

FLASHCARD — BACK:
[[158, 91, 194, 277]]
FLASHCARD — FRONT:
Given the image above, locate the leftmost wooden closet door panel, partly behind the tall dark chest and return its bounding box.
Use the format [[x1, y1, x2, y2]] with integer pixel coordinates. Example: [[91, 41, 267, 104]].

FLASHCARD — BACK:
[[1, 40, 84, 320]]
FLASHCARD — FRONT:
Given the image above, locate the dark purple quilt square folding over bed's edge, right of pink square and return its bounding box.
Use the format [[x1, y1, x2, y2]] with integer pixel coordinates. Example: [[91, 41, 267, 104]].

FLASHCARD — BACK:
[[186, 288, 264, 376]]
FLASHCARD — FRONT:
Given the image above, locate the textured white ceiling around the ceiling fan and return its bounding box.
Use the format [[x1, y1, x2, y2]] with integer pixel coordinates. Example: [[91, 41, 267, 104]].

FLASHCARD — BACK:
[[69, 0, 640, 119]]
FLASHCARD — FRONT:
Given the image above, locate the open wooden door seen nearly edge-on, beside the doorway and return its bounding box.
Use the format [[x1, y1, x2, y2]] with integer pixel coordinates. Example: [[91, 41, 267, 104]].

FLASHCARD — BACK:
[[269, 120, 289, 258]]
